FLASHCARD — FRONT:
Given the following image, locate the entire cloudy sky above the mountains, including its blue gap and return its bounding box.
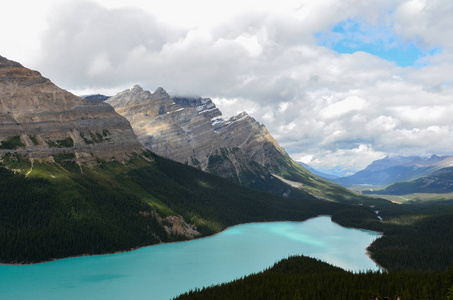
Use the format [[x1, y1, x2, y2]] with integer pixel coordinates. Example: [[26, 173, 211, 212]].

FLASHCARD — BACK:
[[0, 0, 453, 173]]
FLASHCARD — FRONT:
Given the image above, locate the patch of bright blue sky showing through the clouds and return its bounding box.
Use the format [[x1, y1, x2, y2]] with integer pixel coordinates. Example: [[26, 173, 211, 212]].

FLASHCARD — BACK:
[[315, 19, 441, 67]]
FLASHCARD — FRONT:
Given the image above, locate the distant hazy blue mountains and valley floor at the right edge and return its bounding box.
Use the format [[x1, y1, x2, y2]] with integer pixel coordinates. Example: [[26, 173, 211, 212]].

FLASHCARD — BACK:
[[314, 155, 453, 203]]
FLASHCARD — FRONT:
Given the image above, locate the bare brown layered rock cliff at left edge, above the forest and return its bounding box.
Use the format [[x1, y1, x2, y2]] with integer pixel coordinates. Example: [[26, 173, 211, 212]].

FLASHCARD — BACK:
[[0, 56, 143, 162]]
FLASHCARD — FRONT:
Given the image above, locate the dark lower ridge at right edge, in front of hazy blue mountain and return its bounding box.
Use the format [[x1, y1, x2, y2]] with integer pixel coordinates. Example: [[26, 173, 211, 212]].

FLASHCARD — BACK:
[[363, 167, 453, 195]]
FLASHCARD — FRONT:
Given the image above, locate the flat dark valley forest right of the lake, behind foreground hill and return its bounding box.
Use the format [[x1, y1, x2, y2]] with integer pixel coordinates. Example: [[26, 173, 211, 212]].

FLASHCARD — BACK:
[[332, 203, 453, 271]]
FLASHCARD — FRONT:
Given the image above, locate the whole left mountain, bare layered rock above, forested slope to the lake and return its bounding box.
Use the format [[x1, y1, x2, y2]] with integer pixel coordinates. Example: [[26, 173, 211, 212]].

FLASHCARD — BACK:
[[0, 57, 379, 263]]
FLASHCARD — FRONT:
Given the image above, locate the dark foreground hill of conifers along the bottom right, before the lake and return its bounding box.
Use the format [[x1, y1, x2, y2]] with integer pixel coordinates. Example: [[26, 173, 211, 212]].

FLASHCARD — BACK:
[[175, 256, 453, 300]]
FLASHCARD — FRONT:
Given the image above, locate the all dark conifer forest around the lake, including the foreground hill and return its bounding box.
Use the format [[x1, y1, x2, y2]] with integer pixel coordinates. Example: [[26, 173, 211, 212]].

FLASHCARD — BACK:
[[0, 152, 453, 299]]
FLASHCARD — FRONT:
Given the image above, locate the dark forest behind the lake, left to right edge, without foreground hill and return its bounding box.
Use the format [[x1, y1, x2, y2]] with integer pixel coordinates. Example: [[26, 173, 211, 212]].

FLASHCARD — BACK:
[[0, 152, 453, 270]]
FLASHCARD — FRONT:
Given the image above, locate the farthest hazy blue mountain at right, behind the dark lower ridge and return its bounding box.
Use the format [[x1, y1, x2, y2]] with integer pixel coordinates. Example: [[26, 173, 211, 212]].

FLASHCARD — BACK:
[[332, 155, 453, 186]]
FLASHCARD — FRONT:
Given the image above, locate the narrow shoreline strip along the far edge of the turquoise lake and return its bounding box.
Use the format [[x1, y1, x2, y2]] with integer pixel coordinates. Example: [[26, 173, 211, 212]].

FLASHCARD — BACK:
[[0, 215, 386, 271]]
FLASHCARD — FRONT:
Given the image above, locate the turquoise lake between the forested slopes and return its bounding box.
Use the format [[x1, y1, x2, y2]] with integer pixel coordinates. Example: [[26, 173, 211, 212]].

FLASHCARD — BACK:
[[0, 216, 380, 300]]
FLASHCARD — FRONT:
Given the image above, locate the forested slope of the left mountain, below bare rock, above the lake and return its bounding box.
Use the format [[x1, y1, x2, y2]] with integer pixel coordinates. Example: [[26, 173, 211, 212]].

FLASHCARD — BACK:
[[0, 153, 367, 263]]
